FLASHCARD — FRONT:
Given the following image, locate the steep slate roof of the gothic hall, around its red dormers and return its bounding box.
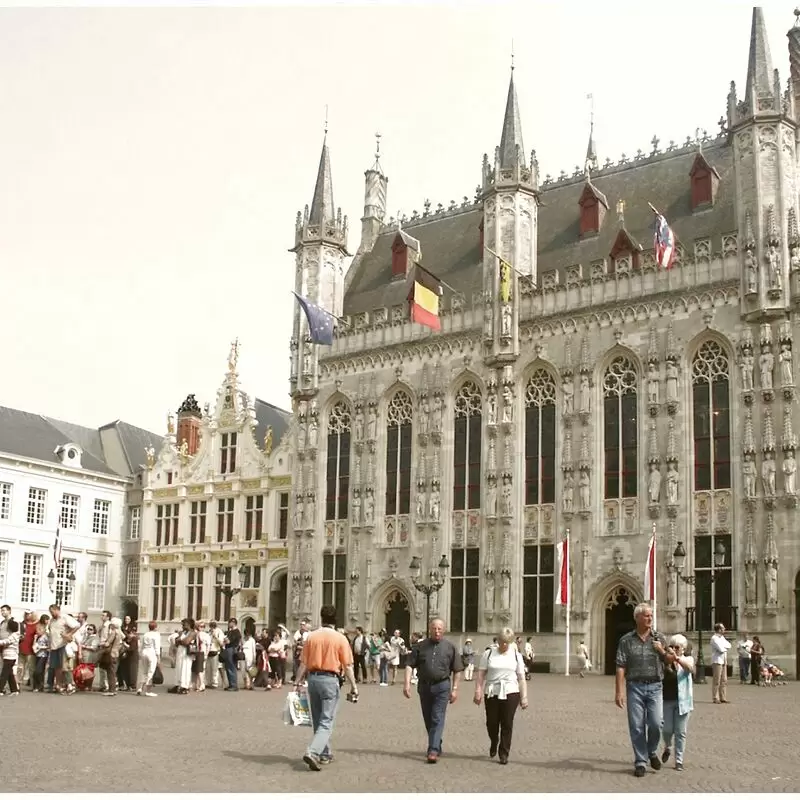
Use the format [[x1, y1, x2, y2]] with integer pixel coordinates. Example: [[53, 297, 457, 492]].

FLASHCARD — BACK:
[[344, 140, 738, 314]]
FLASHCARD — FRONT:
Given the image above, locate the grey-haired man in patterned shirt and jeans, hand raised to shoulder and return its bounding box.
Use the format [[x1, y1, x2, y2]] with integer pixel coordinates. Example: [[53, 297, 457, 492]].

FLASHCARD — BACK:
[[615, 603, 675, 778]]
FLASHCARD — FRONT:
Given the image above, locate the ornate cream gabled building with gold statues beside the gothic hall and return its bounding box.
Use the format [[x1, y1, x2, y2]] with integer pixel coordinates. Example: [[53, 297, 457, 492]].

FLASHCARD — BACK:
[[133, 344, 291, 631]]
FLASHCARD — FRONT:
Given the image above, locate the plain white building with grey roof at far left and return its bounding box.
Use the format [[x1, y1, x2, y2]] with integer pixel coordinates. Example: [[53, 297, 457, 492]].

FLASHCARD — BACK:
[[0, 407, 161, 619]]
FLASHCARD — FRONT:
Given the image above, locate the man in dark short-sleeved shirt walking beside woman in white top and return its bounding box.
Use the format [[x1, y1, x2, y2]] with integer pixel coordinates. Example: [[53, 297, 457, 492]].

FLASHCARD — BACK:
[[403, 619, 464, 764]]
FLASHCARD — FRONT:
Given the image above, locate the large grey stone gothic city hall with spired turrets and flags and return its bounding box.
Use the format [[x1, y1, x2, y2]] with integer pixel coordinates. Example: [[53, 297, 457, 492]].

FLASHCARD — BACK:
[[288, 8, 800, 673]]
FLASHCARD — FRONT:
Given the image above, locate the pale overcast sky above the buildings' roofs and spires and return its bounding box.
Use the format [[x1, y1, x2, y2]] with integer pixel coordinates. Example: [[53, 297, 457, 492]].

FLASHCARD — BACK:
[[0, 0, 794, 433]]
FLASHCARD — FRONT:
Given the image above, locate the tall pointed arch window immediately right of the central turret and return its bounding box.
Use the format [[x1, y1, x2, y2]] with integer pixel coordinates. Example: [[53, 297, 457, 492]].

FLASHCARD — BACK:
[[525, 369, 556, 506]]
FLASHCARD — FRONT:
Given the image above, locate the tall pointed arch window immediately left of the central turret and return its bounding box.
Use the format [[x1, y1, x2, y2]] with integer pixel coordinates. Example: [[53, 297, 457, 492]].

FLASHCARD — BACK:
[[453, 381, 483, 511]]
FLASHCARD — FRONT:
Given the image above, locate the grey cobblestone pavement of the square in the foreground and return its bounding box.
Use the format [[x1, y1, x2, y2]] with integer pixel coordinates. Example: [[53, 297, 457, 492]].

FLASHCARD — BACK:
[[6, 673, 800, 792]]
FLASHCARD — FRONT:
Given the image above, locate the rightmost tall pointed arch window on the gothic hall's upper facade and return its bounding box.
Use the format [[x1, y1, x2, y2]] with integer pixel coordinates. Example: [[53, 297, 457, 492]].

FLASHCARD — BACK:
[[692, 341, 731, 491]]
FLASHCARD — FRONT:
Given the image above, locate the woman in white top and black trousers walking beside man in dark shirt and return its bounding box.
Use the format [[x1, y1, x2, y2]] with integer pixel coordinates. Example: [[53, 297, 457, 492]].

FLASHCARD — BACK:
[[473, 628, 528, 764]]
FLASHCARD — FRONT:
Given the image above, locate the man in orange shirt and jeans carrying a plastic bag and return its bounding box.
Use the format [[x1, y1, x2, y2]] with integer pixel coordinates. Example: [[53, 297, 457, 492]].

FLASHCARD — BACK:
[[294, 606, 358, 772]]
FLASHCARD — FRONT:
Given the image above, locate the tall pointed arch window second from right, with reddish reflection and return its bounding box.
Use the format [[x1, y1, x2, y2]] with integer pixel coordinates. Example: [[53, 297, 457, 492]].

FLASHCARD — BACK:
[[603, 356, 639, 500]]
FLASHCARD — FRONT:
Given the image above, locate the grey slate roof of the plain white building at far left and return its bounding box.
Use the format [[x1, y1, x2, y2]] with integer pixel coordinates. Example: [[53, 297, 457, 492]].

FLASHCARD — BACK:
[[0, 406, 161, 477]]
